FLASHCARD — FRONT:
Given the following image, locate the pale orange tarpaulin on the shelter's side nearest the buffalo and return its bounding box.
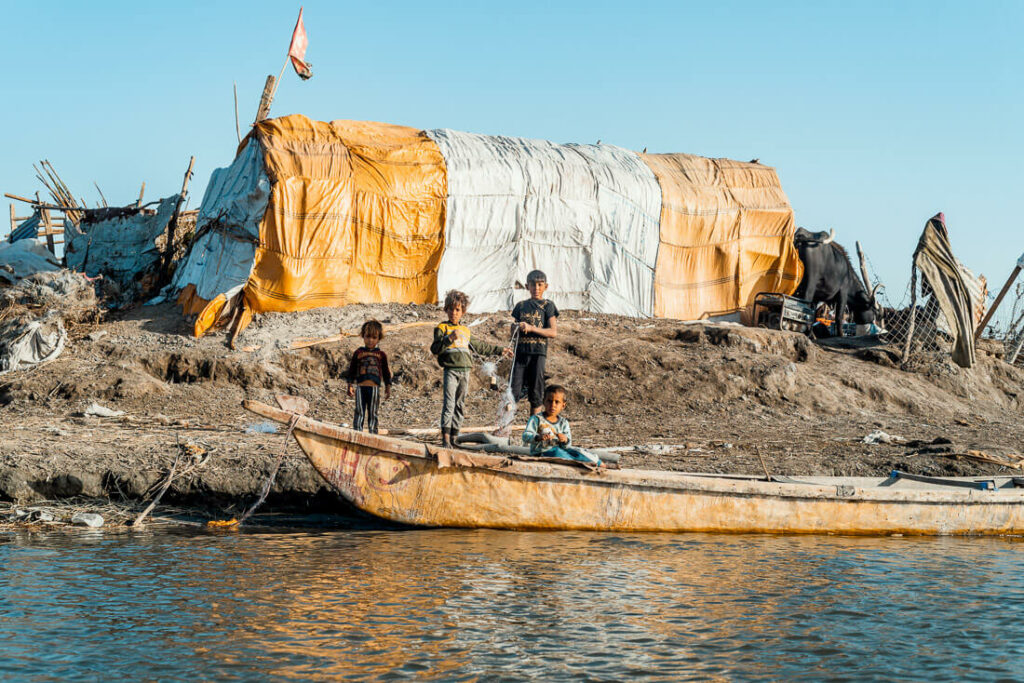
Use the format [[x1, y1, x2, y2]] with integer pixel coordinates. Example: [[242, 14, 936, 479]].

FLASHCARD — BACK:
[[641, 155, 803, 319]]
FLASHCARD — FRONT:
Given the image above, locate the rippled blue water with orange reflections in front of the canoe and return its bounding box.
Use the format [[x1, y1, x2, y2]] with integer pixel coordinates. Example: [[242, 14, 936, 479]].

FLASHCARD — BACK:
[[0, 529, 1024, 681]]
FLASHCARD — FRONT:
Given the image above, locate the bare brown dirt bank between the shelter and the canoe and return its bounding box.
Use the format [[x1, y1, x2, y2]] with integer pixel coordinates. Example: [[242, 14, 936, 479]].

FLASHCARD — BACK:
[[0, 305, 1024, 514]]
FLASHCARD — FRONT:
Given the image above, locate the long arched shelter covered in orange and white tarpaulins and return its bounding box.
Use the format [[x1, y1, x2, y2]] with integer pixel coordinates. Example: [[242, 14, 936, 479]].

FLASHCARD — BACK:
[[174, 115, 802, 334]]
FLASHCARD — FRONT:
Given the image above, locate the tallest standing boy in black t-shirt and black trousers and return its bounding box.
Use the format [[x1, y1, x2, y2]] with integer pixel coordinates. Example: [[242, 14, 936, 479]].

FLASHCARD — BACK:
[[512, 270, 558, 415]]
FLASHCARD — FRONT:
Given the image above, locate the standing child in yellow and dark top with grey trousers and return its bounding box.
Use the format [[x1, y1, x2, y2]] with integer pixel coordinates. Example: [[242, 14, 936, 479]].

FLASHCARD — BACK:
[[430, 290, 512, 446]]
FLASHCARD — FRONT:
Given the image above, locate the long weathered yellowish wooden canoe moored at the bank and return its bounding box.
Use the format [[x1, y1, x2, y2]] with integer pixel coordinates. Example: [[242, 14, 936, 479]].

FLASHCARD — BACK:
[[244, 400, 1024, 535]]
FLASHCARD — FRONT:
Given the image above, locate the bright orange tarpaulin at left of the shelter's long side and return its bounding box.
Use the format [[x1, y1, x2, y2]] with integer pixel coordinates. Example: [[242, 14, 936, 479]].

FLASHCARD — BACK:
[[245, 115, 446, 312]]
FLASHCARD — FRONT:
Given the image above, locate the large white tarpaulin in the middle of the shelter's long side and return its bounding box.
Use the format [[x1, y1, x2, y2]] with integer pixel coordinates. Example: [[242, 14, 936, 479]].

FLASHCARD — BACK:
[[427, 129, 662, 316]]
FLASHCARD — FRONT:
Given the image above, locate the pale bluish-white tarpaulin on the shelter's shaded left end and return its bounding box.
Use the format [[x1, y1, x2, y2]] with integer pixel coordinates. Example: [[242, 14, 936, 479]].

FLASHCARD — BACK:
[[173, 140, 270, 301]]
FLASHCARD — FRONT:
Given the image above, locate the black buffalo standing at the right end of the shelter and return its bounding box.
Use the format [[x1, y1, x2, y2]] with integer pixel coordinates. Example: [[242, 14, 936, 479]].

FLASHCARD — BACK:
[[794, 227, 878, 334]]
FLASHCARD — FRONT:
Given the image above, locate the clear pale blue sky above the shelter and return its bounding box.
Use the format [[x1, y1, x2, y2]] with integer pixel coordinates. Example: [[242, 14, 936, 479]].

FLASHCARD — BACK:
[[0, 0, 1024, 321]]
